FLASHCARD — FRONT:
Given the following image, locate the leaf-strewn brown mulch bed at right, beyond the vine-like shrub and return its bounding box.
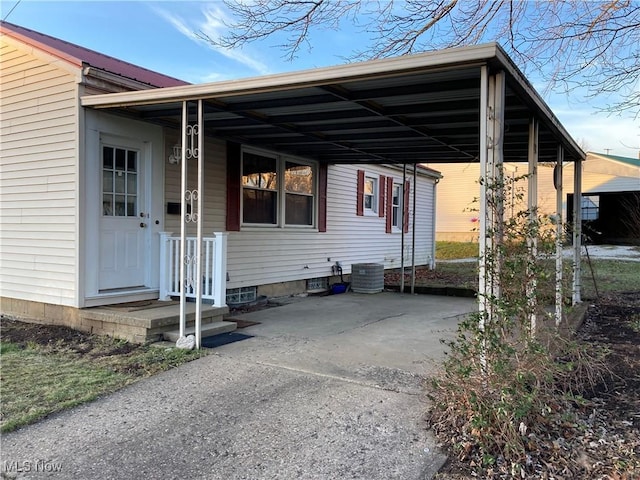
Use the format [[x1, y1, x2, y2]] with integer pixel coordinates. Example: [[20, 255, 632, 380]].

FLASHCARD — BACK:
[[437, 292, 640, 480]]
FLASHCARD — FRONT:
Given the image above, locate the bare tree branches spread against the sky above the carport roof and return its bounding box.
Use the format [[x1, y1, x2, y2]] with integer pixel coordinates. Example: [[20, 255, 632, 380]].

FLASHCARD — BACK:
[[209, 0, 640, 117]]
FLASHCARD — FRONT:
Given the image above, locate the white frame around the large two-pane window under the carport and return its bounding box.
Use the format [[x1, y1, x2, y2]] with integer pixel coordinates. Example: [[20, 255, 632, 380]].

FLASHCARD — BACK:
[[238, 145, 321, 231]]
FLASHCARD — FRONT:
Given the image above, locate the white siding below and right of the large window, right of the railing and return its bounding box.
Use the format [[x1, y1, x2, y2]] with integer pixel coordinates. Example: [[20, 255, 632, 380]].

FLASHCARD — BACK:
[[227, 165, 433, 288]]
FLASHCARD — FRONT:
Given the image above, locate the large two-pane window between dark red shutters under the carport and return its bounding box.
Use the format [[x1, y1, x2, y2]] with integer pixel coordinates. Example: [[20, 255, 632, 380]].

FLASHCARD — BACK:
[[242, 151, 317, 227]]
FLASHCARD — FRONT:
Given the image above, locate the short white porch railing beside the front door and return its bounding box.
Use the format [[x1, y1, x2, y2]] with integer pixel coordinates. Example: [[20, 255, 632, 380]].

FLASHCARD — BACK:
[[160, 232, 227, 307]]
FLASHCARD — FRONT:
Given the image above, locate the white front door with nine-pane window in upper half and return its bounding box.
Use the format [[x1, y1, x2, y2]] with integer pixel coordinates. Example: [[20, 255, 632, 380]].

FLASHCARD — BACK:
[[98, 143, 149, 291]]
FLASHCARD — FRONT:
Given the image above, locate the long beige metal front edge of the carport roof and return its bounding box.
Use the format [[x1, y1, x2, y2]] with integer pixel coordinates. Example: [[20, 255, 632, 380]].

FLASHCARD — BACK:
[[81, 43, 499, 108]]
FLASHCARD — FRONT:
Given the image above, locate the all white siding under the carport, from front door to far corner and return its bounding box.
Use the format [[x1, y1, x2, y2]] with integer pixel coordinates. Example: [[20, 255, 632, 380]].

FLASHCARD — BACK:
[[165, 148, 433, 289]]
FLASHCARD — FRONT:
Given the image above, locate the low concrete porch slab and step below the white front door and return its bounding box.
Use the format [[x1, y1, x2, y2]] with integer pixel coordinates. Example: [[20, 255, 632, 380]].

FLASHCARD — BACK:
[[80, 302, 231, 343]]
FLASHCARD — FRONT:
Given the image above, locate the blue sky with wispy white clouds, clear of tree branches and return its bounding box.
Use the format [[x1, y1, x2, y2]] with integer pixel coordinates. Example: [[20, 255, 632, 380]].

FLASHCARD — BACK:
[[0, 0, 640, 158]]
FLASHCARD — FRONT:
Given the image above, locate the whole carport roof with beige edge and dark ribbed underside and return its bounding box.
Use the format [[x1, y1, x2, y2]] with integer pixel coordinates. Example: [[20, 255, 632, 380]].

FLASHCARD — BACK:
[[82, 44, 584, 164]]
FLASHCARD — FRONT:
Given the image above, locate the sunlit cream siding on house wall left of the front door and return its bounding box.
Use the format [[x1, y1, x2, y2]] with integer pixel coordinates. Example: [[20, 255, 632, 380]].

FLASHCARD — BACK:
[[0, 38, 79, 306]]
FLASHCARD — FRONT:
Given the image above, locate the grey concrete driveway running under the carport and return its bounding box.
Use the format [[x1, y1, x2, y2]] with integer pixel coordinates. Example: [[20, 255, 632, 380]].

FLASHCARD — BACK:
[[1, 292, 476, 480]]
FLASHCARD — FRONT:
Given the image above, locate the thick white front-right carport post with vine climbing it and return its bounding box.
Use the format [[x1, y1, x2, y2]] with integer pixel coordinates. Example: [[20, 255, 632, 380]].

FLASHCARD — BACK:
[[478, 66, 505, 336]]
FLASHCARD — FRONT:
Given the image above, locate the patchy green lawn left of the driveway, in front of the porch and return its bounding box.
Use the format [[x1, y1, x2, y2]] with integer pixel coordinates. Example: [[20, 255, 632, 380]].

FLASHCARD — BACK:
[[0, 332, 206, 433]]
